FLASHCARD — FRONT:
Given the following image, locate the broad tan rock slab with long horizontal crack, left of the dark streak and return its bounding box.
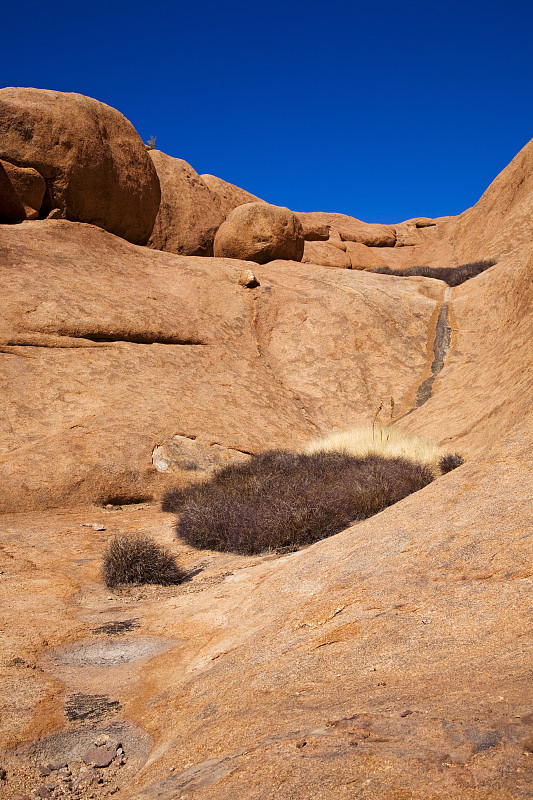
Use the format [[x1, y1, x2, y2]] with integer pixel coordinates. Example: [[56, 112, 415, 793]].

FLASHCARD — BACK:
[[0, 220, 435, 510]]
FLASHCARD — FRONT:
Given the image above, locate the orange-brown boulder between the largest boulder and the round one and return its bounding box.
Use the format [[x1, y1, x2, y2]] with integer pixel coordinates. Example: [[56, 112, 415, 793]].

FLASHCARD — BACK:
[[148, 150, 224, 256]]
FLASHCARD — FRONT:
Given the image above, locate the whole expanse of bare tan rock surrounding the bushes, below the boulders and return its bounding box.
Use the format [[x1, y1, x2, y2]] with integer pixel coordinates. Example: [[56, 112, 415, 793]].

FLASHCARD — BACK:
[[0, 123, 533, 800]]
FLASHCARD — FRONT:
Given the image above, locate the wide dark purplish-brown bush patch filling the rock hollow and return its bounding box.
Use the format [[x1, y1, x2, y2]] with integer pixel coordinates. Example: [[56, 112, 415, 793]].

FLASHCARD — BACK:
[[168, 451, 434, 554]]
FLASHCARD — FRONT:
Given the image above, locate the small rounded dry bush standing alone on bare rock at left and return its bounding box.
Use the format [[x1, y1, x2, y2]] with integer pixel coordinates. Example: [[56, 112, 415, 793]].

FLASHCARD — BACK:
[[103, 534, 185, 588]]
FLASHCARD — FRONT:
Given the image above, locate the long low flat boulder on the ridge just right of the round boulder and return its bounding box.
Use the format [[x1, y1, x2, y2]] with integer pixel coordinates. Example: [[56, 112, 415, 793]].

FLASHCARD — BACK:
[[298, 211, 396, 247]]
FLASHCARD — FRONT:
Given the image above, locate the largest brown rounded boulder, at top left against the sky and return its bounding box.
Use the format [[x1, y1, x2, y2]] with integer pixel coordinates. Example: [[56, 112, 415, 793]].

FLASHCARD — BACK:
[[0, 88, 160, 244]]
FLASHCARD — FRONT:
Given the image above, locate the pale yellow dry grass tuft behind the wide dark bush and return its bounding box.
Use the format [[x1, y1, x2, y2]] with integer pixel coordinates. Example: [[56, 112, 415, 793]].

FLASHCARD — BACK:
[[306, 425, 442, 476]]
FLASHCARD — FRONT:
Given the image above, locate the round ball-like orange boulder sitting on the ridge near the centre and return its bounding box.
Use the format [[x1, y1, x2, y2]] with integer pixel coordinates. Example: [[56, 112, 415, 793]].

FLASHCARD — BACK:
[[215, 202, 304, 264]]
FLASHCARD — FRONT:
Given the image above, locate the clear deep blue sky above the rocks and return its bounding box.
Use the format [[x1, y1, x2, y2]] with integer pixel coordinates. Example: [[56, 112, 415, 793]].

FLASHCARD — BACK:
[[0, 0, 533, 222]]
